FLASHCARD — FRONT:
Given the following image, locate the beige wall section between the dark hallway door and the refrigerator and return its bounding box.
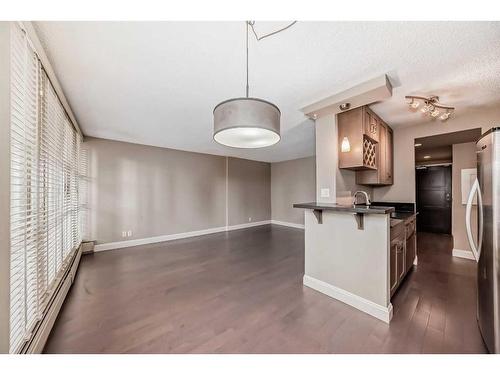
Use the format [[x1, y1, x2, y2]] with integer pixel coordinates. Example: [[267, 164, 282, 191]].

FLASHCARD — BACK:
[[451, 142, 477, 251]]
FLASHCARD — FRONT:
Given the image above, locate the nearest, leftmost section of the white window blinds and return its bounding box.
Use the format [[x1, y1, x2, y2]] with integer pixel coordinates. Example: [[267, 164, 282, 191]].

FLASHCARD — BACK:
[[10, 21, 39, 351]]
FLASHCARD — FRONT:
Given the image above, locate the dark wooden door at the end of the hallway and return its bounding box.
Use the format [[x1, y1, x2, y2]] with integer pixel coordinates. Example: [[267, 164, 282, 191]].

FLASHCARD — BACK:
[[416, 166, 451, 234]]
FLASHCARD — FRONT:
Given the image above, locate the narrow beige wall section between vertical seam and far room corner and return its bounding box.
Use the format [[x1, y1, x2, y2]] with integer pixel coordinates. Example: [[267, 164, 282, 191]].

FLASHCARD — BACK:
[[228, 158, 271, 225]]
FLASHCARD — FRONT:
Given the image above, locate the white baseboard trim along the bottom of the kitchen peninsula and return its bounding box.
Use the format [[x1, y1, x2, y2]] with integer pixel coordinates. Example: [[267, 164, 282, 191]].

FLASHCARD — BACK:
[[303, 275, 392, 323]]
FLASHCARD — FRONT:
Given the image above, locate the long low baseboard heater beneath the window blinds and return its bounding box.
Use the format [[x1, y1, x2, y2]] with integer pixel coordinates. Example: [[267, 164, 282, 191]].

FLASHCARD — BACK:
[[20, 245, 82, 354]]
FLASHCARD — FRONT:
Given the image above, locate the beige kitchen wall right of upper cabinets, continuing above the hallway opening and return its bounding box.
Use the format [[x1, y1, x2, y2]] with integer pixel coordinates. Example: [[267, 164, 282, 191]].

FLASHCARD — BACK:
[[373, 105, 500, 202]]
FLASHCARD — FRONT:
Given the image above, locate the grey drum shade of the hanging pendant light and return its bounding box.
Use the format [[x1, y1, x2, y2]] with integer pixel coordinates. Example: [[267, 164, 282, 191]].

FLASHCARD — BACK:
[[214, 98, 281, 148]]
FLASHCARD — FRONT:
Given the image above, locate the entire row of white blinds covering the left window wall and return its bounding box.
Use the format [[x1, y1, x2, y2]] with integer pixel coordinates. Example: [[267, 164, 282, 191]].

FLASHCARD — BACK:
[[10, 23, 81, 353]]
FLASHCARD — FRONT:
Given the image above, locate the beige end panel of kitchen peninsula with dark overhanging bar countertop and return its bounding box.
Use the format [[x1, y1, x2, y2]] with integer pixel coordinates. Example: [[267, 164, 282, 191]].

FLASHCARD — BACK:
[[294, 202, 394, 323]]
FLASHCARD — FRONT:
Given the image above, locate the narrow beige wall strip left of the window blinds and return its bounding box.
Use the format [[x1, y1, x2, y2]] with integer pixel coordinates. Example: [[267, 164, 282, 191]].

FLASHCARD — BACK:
[[0, 22, 10, 353]]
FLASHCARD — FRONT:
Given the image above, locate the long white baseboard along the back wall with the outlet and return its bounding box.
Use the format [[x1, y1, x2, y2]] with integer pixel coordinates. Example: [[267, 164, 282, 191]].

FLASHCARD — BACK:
[[94, 220, 271, 252]]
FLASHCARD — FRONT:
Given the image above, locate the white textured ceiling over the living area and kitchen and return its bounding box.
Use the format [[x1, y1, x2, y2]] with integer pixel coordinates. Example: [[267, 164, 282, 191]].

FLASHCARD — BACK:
[[35, 22, 500, 162]]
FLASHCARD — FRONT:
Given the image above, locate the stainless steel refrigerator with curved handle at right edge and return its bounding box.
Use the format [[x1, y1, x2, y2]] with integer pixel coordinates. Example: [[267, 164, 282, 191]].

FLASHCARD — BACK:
[[465, 127, 500, 353]]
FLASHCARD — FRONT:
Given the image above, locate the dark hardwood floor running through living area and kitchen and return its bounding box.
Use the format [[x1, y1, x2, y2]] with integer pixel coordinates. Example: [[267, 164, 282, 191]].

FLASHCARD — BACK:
[[45, 225, 485, 353]]
